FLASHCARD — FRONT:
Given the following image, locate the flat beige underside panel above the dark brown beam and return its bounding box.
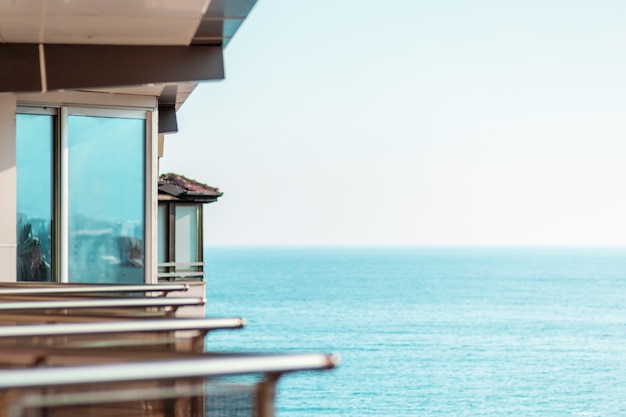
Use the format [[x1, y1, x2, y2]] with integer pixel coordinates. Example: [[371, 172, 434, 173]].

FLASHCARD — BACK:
[[0, 0, 210, 45]]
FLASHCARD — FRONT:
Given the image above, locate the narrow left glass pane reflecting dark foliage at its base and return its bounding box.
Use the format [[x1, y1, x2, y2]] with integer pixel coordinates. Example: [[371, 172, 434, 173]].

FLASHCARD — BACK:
[[16, 114, 56, 281]]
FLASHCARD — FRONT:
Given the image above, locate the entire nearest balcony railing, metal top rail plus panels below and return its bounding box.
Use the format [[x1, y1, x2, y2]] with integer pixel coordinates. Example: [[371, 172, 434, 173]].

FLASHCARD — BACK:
[[0, 354, 339, 417]]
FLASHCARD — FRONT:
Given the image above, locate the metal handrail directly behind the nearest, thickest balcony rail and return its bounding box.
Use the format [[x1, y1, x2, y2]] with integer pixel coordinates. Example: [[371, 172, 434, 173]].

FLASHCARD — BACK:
[[0, 318, 246, 340]]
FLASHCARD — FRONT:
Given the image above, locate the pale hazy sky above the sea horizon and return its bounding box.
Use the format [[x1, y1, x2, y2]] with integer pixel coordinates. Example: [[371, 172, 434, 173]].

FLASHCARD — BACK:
[[161, 0, 626, 245]]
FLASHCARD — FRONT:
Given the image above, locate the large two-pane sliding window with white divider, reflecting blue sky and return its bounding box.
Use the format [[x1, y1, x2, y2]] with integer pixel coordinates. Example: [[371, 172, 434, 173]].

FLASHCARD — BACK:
[[17, 108, 147, 283]]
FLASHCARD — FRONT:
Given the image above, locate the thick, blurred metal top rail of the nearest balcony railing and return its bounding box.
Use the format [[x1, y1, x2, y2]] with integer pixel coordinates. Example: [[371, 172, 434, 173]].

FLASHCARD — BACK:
[[0, 354, 340, 390]]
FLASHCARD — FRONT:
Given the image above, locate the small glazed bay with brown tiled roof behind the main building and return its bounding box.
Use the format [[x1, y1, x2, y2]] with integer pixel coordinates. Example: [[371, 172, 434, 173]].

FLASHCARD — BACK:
[[158, 174, 222, 280]]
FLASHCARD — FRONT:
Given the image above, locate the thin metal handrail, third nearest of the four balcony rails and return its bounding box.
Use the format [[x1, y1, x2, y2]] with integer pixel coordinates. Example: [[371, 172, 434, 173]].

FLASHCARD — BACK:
[[0, 297, 206, 311]]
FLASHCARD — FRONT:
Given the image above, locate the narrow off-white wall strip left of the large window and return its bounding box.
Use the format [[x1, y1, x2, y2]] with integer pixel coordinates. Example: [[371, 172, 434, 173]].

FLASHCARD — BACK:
[[0, 94, 17, 282]]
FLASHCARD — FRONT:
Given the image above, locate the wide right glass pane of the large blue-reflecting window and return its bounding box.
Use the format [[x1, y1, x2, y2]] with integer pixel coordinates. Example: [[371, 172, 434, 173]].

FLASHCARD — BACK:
[[67, 116, 146, 283]]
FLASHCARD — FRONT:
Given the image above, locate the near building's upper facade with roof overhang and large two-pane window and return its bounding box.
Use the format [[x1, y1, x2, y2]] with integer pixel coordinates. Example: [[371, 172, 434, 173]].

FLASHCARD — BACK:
[[0, 0, 255, 283]]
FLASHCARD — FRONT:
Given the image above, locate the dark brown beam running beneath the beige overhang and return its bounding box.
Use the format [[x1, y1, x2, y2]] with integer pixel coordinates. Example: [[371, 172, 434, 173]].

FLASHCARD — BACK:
[[0, 44, 224, 92]]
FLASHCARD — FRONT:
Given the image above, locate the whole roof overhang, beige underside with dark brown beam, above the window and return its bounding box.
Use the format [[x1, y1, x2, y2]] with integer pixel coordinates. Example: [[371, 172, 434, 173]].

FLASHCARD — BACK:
[[0, 0, 256, 108]]
